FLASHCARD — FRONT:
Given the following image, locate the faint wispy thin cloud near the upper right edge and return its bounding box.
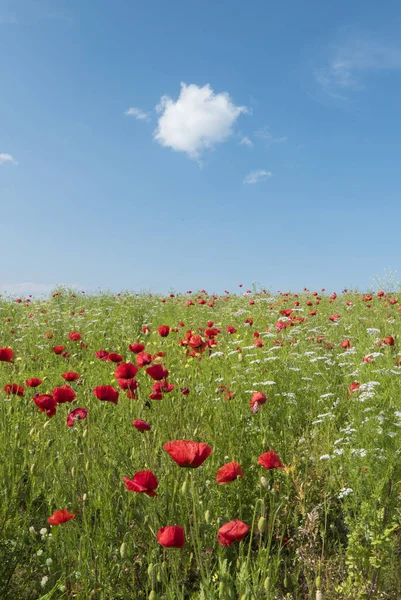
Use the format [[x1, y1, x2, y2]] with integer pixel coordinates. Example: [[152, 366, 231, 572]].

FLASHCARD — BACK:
[[314, 34, 401, 99]]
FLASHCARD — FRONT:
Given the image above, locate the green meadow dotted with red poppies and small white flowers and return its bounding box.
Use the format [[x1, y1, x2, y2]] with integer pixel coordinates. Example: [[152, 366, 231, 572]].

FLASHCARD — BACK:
[[0, 289, 401, 600]]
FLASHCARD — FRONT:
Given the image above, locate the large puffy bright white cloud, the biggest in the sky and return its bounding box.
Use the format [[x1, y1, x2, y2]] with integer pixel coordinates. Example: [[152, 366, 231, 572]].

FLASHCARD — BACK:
[[154, 83, 248, 160]]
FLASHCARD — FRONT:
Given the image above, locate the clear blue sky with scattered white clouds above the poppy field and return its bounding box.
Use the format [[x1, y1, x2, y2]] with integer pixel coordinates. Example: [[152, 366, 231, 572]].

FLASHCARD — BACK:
[[0, 0, 401, 294]]
